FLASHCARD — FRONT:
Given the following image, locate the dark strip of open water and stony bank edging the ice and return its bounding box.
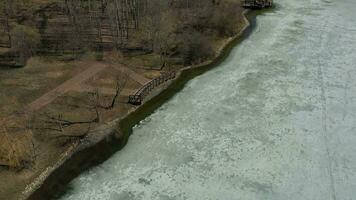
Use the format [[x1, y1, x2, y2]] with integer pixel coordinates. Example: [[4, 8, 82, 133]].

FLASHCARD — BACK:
[[24, 10, 258, 200]]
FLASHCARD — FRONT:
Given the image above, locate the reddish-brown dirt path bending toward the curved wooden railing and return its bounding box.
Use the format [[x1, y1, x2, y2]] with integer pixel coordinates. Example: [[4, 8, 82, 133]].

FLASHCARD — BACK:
[[26, 63, 150, 111]]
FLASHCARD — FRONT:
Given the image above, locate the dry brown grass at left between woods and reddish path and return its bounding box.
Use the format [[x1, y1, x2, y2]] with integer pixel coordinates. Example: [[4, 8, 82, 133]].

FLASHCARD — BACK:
[[0, 58, 91, 115]]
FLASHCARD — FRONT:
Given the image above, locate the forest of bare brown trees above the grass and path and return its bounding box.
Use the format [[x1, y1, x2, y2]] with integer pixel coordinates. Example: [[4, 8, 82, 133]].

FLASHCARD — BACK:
[[0, 0, 240, 65]]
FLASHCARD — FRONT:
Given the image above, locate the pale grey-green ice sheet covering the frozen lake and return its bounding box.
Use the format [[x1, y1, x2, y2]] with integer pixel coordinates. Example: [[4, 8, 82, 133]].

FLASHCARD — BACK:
[[62, 0, 356, 200]]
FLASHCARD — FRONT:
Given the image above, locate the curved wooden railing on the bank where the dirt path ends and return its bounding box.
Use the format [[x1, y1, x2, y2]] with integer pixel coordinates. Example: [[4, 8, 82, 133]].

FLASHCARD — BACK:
[[129, 71, 176, 105]]
